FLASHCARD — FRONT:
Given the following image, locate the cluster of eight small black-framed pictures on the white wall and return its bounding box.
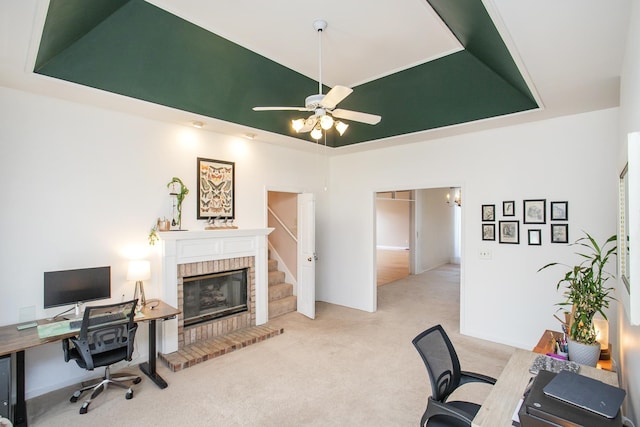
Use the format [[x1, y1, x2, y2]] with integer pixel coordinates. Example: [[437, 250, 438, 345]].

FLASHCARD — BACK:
[[482, 199, 569, 246]]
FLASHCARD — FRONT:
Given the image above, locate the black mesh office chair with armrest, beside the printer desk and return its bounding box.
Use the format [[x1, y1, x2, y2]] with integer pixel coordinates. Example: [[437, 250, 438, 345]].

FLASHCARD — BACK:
[[412, 325, 496, 427]]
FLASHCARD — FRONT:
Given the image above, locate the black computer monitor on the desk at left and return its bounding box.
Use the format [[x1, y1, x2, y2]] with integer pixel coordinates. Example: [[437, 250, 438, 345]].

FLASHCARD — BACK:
[[44, 267, 111, 316]]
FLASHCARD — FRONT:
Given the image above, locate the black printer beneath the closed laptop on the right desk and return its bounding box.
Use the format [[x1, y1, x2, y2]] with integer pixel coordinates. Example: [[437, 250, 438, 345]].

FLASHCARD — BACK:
[[518, 370, 622, 427]]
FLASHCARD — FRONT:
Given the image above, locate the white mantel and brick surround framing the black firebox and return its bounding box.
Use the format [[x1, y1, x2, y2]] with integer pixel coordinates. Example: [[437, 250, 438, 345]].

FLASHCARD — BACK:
[[158, 228, 273, 354]]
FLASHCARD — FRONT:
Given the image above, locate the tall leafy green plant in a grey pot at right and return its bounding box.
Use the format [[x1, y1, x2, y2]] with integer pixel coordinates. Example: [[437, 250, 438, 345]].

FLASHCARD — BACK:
[[538, 232, 617, 366]]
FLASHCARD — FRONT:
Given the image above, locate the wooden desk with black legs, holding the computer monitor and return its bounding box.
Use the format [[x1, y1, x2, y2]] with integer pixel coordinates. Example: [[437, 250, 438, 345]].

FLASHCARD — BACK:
[[0, 300, 180, 427]]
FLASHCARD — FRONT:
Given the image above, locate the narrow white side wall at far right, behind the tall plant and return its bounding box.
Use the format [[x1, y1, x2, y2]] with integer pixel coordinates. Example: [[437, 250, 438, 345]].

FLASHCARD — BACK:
[[615, 0, 640, 426]]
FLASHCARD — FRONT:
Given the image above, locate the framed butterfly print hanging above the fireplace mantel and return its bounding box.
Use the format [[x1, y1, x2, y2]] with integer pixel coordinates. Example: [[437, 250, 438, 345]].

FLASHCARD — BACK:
[[197, 157, 235, 219]]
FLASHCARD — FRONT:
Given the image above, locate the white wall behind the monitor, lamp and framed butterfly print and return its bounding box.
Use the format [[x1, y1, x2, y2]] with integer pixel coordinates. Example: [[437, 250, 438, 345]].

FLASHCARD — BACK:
[[0, 87, 326, 397]]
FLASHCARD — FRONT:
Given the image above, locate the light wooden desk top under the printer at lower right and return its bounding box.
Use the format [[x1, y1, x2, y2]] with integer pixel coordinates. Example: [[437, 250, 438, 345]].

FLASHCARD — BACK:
[[472, 349, 618, 427]]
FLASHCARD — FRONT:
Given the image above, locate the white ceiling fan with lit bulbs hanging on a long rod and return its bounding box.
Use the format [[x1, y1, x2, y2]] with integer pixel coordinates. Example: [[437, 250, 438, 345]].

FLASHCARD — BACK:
[[253, 19, 382, 139]]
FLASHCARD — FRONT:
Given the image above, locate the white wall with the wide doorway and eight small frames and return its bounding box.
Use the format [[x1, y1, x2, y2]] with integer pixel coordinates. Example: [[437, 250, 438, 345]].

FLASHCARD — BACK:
[[324, 109, 618, 348]]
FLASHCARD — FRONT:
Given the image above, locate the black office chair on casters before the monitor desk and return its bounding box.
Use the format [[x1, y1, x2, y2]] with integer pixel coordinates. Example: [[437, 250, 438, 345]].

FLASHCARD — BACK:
[[62, 300, 140, 414]]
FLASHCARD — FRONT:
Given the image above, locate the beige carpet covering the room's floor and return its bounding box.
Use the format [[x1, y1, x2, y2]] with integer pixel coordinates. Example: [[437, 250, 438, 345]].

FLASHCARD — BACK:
[[27, 266, 512, 427]]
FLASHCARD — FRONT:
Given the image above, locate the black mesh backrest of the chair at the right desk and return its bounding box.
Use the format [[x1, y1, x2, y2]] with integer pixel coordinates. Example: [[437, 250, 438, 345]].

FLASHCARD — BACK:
[[413, 325, 460, 402]]
